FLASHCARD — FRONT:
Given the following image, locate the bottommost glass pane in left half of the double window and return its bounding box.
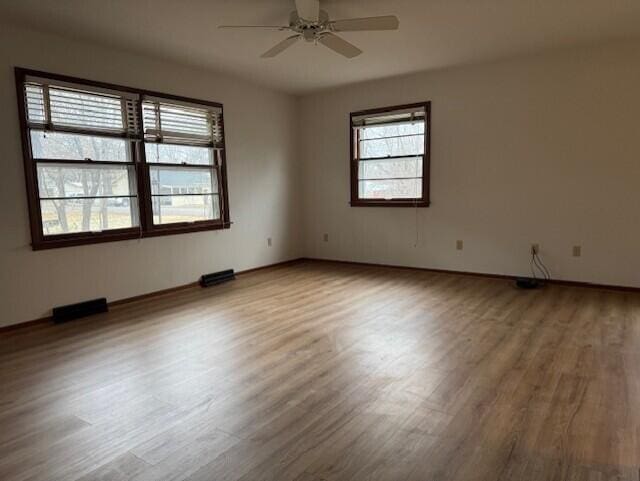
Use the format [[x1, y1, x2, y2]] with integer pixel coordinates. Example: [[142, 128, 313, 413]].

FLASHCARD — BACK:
[[40, 197, 138, 235]]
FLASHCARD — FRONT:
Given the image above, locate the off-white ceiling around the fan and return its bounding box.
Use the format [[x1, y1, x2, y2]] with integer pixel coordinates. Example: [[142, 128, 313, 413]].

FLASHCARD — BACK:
[[0, 0, 640, 94]]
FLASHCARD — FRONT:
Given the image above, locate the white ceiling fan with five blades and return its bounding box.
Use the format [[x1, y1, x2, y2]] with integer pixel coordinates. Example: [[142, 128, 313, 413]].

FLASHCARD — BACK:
[[218, 0, 399, 58]]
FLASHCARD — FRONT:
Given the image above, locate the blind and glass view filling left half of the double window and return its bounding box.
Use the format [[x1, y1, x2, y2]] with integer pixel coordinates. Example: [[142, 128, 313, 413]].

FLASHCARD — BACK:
[[27, 85, 138, 235]]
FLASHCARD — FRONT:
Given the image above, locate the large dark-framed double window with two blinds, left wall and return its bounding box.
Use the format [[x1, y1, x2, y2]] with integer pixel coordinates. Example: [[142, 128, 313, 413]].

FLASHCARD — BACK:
[[16, 69, 230, 249]]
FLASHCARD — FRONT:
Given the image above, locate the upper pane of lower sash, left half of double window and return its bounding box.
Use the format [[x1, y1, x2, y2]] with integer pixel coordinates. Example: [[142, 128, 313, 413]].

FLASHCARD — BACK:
[[38, 164, 136, 198]]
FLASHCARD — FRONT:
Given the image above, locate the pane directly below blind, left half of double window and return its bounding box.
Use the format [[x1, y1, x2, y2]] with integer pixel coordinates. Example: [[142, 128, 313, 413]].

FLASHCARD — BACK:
[[31, 130, 130, 162]]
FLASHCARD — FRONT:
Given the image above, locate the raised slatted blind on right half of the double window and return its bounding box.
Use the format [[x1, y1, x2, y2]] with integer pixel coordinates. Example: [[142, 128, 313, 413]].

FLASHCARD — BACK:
[[142, 98, 222, 147]]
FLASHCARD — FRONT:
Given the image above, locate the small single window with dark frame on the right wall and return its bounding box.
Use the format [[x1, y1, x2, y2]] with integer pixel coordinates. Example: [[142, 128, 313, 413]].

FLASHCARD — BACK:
[[350, 102, 430, 207]]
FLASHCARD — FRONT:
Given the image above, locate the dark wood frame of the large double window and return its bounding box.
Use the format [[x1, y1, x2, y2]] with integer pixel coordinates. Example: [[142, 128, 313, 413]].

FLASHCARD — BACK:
[[15, 67, 231, 250]]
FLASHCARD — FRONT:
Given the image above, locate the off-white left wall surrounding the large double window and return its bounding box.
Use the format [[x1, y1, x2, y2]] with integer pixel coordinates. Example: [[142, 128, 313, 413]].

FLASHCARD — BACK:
[[0, 26, 301, 326]]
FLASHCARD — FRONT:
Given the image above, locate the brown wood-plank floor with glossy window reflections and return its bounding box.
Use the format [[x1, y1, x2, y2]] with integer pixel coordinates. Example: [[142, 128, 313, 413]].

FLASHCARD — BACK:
[[0, 262, 640, 481]]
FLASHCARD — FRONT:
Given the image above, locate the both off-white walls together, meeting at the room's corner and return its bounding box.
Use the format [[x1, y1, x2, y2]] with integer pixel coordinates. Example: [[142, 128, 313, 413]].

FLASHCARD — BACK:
[[0, 27, 640, 326]]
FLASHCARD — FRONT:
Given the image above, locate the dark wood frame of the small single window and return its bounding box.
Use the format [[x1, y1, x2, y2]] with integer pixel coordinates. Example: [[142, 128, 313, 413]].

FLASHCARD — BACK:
[[349, 101, 431, 207]]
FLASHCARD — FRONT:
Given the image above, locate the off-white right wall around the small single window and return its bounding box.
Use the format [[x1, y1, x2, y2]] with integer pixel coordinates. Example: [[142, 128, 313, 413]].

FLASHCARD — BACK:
[[302, 43, 640, 287]]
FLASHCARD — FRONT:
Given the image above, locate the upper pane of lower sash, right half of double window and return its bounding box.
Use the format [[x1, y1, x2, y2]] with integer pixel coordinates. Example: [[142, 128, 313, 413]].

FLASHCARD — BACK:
[[150, 167, 218, 195]]
